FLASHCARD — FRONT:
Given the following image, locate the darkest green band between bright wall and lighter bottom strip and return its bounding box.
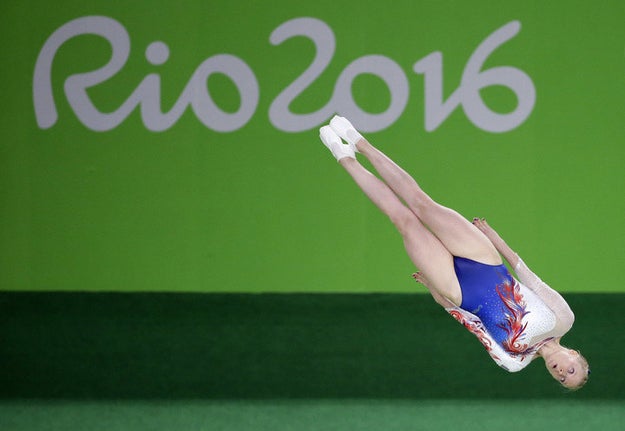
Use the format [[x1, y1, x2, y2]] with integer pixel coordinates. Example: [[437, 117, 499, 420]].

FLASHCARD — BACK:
[[0, 292, 625, 400]]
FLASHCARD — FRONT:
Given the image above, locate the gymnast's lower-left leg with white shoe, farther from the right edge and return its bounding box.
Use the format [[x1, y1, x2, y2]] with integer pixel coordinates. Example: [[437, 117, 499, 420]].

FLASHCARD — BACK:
[[321, 127, 462, 307]]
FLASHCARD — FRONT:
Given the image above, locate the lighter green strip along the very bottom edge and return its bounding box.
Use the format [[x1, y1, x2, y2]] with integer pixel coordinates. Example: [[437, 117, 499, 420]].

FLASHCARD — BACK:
[[0, 399, 625, 431]]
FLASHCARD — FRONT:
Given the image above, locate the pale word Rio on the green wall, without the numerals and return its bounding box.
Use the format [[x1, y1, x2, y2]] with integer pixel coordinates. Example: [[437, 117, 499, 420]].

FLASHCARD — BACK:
[[33, 16, 259, 132]]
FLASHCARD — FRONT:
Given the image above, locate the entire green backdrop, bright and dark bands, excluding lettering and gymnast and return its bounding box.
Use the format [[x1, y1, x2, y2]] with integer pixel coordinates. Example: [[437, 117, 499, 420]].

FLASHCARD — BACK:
[[0, 0, 625, 431]]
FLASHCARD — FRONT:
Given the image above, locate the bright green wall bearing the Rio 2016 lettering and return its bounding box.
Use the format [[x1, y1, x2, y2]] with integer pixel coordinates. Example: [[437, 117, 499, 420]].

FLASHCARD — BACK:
[[0, 0, 625, 292]]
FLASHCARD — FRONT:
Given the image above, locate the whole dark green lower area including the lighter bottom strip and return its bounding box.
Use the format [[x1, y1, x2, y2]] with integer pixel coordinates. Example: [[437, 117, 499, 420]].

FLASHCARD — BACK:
[[0, 292, 625, 431]]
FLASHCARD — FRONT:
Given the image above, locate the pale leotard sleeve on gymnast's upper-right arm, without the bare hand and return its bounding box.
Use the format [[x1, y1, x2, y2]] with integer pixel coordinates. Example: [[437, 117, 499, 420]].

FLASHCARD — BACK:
[[514, 258, 575, 337]]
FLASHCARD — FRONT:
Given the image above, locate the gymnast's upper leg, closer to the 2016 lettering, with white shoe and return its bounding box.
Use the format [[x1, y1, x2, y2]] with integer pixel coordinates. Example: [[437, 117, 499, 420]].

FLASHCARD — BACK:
[[330, 117, 502, 266]]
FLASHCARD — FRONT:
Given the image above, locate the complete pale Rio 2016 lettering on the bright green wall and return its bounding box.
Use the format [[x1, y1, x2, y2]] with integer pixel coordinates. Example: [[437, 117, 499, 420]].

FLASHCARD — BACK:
[[33, 16, 536, 133]]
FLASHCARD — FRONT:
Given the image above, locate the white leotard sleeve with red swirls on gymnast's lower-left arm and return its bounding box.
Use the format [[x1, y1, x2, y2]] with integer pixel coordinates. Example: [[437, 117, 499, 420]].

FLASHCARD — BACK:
[[445, 307, 537, 373]]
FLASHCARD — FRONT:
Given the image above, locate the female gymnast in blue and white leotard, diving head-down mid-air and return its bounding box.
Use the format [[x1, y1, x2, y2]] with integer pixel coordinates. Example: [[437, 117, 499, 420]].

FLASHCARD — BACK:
[[319, 116, 590, 389]]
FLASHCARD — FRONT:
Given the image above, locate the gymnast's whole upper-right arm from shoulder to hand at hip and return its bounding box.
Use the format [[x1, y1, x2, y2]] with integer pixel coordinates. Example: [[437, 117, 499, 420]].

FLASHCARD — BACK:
[[473, 219, 575, 334]]
